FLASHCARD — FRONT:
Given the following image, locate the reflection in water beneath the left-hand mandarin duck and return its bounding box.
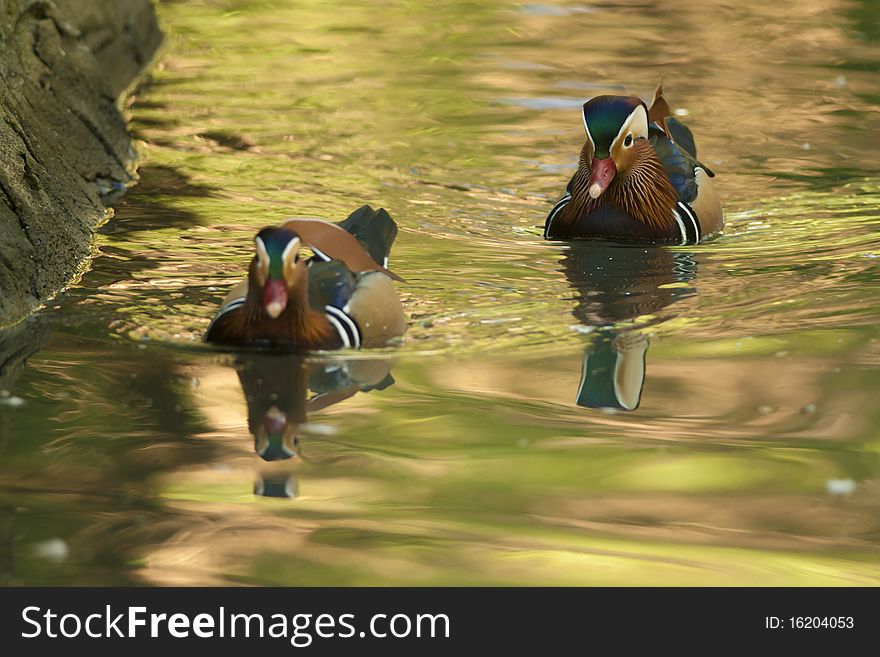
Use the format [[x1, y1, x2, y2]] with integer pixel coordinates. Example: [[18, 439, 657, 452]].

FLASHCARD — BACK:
[[235, 353, 394, 497]]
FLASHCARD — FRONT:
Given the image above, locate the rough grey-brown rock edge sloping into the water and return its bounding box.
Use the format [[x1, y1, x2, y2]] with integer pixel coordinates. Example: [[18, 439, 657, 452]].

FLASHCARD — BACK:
[[0, 0, 162, 328]]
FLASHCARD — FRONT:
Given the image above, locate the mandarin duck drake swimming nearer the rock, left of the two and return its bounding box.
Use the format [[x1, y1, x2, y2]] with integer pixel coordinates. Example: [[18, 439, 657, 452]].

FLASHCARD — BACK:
[[205, 205, 406, 350]]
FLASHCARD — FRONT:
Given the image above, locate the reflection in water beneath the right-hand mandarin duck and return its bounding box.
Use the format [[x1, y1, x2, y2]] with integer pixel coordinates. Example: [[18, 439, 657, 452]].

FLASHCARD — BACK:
[[562, 241, 697, 411]]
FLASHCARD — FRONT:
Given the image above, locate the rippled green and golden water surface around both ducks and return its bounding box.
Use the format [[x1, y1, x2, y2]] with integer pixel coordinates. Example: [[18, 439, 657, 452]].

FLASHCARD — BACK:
[[0, 0, 880, 585]]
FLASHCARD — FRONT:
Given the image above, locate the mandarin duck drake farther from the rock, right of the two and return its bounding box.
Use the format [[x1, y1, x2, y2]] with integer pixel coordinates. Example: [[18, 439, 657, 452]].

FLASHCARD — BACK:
[[544, 85, 724, 244]]
